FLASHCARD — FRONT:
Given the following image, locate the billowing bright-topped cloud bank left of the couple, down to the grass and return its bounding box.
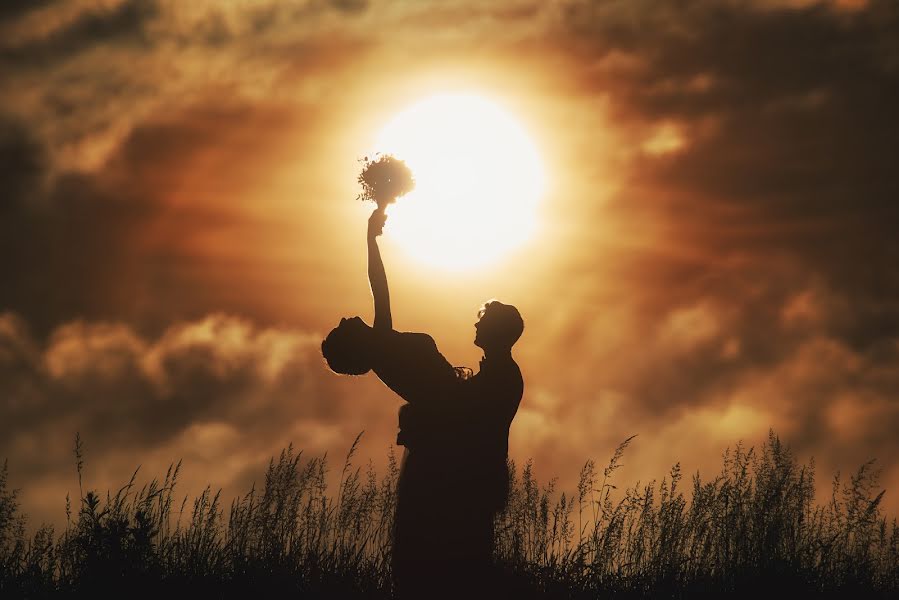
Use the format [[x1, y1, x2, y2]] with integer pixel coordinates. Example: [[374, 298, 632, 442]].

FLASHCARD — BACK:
[[0, 313, 398, 520]]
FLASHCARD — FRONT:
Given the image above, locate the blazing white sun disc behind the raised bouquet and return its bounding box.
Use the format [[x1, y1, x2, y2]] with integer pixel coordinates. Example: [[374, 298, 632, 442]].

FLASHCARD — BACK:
[[377, 94, 545, 270]]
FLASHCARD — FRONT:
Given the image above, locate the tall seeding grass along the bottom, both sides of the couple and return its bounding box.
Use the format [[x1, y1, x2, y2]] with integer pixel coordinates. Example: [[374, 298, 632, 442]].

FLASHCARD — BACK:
[[0, 432, 899, 598]]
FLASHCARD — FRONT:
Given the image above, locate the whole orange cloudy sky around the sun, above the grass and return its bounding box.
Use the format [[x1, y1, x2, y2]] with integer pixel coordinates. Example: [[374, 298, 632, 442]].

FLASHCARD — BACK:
[[0, 0, 899, 524]]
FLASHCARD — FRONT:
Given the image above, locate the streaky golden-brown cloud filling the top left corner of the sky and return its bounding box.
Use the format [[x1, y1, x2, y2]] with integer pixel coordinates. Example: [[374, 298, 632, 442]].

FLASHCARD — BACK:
[[0, 0, 372, 172]]
